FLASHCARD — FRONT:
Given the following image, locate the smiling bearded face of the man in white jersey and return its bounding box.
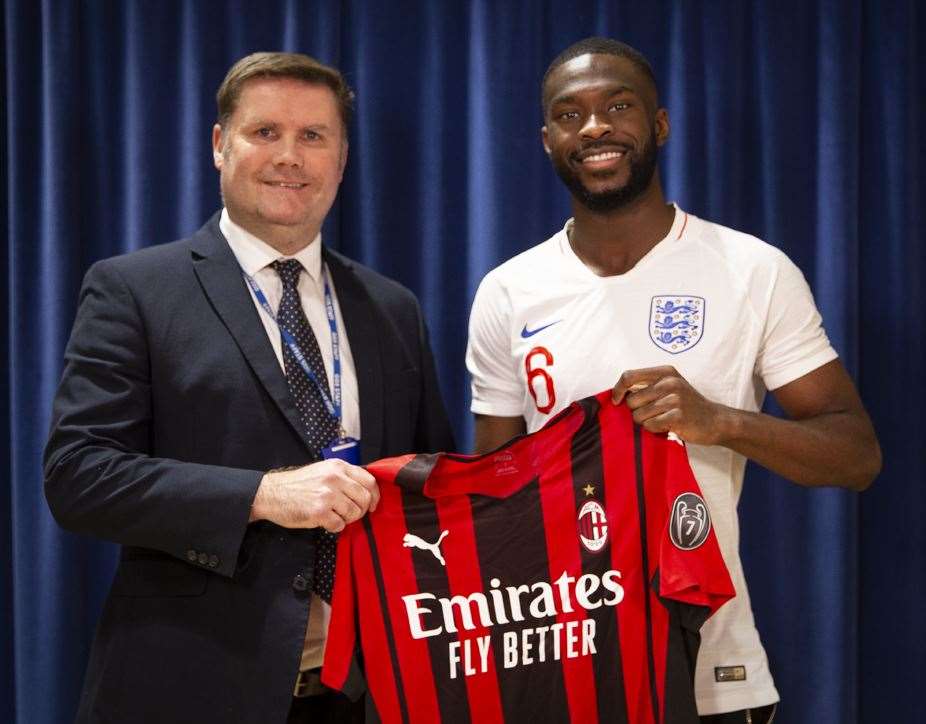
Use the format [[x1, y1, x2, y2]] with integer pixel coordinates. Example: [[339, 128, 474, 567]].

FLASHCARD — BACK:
[[542, 54, 669, 212]]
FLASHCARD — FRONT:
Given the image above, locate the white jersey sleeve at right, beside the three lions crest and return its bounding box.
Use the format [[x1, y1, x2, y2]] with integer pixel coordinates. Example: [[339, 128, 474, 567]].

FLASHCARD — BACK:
[[755, 250, 838, 390]]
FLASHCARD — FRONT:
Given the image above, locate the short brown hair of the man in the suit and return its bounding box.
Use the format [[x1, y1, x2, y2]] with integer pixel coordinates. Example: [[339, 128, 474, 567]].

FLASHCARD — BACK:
[[215, 53, 354, 131]]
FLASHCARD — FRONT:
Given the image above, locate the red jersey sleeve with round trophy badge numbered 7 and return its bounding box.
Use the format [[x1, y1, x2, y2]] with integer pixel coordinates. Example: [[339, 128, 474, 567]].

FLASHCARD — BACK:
[[647, 435, 736, 623]]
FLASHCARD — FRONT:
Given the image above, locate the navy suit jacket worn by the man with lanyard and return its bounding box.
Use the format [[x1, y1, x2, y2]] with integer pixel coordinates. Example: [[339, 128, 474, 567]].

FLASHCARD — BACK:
[[45, 215, 453, 724]]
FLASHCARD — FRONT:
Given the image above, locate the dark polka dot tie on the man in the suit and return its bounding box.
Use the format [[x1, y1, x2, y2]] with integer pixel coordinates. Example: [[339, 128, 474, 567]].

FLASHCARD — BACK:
[[273, 259, 338, 603]]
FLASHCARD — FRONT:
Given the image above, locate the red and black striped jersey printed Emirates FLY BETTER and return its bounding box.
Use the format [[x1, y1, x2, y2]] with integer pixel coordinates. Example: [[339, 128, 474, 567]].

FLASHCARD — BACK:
[[322, 391, 734, 724]]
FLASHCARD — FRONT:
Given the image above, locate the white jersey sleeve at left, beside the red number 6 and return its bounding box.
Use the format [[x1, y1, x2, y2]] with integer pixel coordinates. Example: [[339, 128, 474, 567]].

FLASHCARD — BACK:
[[466, 273, 524, 417]]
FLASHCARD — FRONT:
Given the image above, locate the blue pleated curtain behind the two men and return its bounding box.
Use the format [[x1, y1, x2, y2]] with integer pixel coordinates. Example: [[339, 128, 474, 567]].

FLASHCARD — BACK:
[[0, 0, 926, 724]]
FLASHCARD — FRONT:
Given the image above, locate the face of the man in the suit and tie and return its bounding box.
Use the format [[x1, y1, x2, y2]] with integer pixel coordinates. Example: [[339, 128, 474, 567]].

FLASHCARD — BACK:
[[212, 78, 347, 254]]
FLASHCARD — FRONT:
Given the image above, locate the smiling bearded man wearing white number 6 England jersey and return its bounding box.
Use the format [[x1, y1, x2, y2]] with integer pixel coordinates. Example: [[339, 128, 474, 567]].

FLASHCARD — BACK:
[[467, 38, 881, 724]]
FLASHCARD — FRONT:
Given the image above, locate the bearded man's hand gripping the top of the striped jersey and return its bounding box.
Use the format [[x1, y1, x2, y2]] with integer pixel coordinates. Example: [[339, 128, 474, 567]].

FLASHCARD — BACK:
[[611, 366, 730, 445]]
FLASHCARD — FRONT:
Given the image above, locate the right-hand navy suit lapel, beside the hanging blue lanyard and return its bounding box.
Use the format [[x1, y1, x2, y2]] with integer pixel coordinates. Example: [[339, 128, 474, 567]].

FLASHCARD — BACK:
[[323, 248, 385, 462]]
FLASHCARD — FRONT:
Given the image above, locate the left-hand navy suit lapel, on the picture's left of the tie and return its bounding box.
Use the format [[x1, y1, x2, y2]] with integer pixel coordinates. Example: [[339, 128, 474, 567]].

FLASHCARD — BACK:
[[191, 214, 312, 450]]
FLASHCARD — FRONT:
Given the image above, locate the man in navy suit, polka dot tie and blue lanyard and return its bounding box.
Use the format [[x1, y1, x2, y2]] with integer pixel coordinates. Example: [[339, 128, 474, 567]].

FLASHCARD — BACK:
[[45, 53, 453, 724]]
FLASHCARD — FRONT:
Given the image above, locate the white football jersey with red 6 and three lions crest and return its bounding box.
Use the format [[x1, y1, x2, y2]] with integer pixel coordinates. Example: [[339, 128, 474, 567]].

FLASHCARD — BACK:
[[467, 207, 836, 714]]
